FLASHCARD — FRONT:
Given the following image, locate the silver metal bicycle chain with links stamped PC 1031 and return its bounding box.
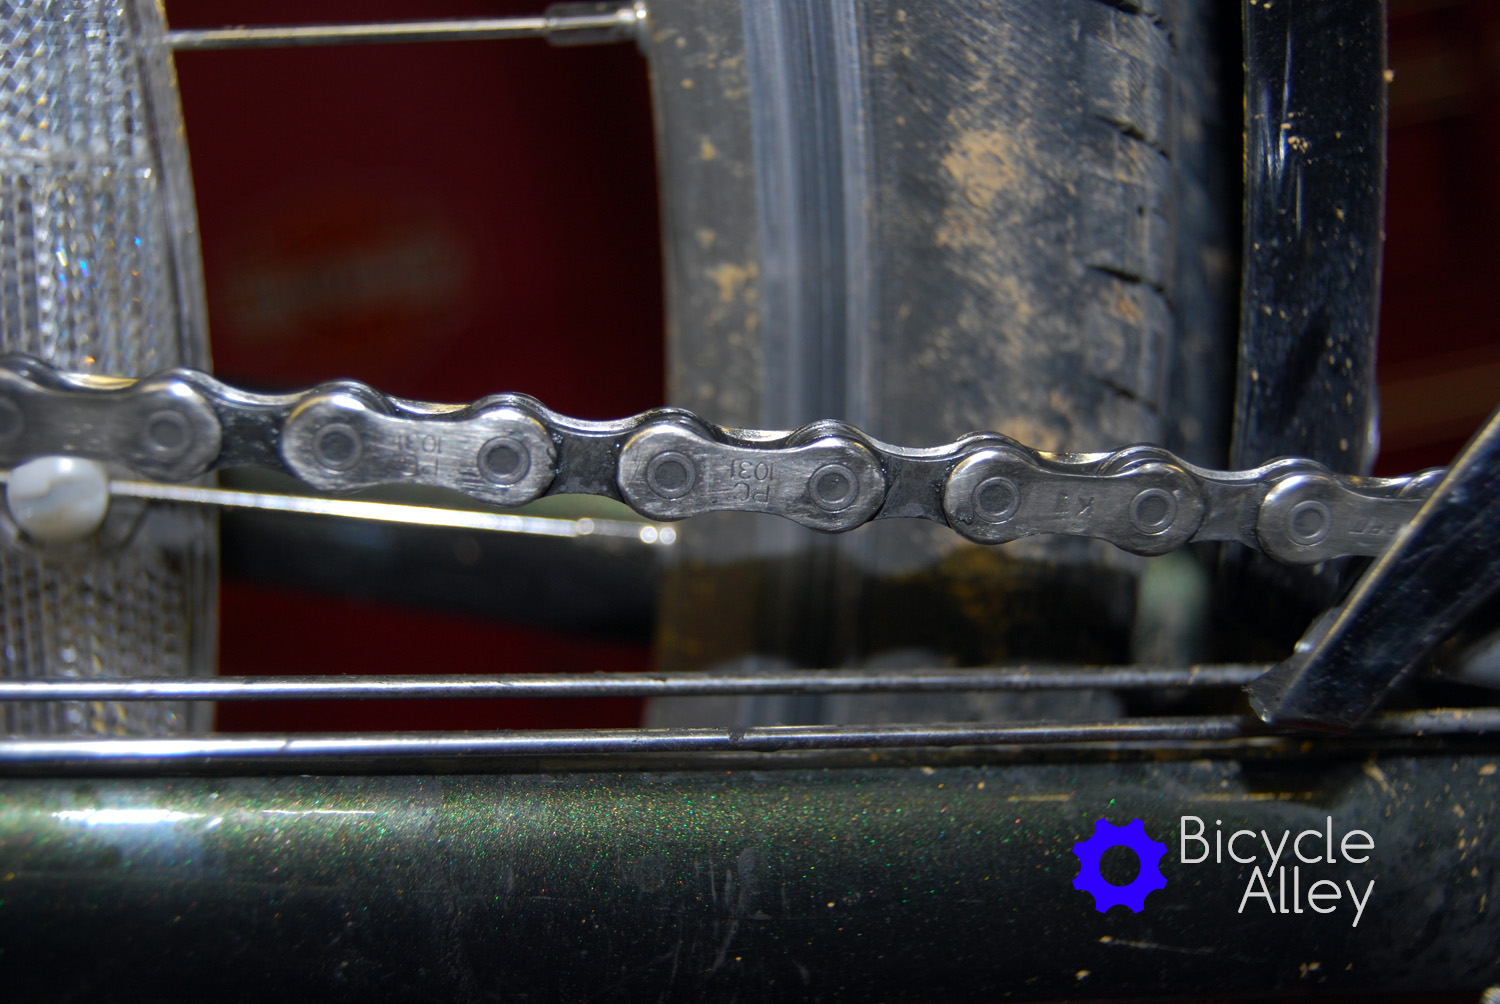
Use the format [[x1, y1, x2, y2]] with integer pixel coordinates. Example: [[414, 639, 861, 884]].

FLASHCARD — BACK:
[[0, 357, 1443, 564]]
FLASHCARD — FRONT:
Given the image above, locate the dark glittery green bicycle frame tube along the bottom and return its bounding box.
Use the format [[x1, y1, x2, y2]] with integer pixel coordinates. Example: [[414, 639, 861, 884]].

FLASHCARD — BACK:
[[0, 756, 1500, 1001]]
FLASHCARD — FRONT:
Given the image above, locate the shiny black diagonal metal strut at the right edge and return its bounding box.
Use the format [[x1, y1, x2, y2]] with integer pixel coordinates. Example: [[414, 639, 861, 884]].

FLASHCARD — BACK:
[[1250, 411, 1500, 728]]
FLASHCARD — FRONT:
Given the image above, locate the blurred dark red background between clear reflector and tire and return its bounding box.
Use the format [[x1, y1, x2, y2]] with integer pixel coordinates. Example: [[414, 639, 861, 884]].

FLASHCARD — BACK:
[[168, 0, 663, 731]]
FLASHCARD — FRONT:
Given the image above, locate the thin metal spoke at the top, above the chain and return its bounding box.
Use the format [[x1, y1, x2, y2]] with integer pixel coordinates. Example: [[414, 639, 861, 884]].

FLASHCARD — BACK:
[[167, 3, 645, 53]]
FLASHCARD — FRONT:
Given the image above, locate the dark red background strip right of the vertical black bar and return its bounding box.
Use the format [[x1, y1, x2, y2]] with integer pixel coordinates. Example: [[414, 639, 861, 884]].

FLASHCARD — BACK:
[[1376, 0, 1500, 474]]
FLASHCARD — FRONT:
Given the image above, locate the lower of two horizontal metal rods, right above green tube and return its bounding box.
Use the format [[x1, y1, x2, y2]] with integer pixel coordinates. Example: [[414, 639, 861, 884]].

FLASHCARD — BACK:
[[0, 708, 1500, 768]]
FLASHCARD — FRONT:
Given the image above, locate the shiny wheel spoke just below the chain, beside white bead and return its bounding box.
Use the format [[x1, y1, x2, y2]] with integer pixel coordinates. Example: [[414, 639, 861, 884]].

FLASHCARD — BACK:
[[101, 477, 677, 545]]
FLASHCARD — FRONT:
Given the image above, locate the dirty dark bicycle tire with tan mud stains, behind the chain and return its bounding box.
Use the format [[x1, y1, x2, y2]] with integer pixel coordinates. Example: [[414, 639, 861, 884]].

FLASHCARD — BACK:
[[651, 0, 1238, 725]]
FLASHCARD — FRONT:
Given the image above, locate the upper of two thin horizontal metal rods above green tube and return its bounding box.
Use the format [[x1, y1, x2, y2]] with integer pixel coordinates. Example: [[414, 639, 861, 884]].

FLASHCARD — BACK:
[[0, 665, 1269, 701]]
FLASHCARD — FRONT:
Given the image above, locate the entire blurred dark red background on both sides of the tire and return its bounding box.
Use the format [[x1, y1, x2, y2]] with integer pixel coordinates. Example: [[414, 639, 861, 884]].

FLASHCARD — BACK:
[[158, 0, 1500, 731]]
